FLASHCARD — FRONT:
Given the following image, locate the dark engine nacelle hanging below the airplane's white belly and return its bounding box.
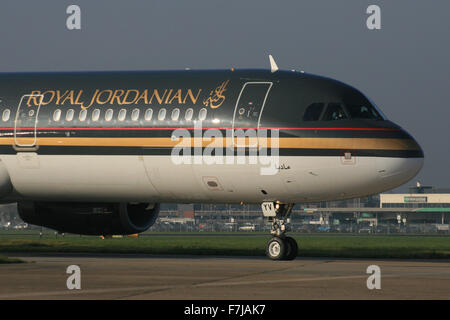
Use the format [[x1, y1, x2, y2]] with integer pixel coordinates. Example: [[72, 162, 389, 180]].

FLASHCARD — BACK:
[[17, 202, 160, 235]]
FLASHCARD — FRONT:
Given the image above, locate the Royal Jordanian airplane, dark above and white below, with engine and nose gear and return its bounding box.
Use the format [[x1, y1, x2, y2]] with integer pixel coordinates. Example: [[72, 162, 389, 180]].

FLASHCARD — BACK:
[[0, 56, 424, 260]]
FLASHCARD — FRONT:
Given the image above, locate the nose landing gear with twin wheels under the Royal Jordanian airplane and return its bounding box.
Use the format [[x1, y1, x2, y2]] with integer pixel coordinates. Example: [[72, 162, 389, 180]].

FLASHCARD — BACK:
[[261, 202, 298, 260]]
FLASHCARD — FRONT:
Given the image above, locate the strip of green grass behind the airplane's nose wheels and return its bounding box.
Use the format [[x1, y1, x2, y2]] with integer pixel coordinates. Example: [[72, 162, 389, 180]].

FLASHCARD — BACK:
[[0, 233, 450, 259]]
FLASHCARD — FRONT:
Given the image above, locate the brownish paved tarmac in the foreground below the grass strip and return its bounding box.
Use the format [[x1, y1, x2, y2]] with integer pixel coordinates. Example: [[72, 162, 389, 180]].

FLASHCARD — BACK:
[[0, 254, 450, 300]]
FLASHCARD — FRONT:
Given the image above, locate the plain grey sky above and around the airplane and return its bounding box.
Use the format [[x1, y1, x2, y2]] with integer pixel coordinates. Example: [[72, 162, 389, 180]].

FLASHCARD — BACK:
[[0, 0, 450, 187]]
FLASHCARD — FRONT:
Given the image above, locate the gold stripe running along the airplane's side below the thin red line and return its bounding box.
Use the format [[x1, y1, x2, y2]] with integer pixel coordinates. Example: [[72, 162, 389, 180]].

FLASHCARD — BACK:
[[0, 137, 420, 150]]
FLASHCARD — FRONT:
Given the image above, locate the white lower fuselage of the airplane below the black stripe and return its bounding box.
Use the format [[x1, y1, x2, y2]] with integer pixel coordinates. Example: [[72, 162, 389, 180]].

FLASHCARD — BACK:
[[1, 152, 423, 203]]
